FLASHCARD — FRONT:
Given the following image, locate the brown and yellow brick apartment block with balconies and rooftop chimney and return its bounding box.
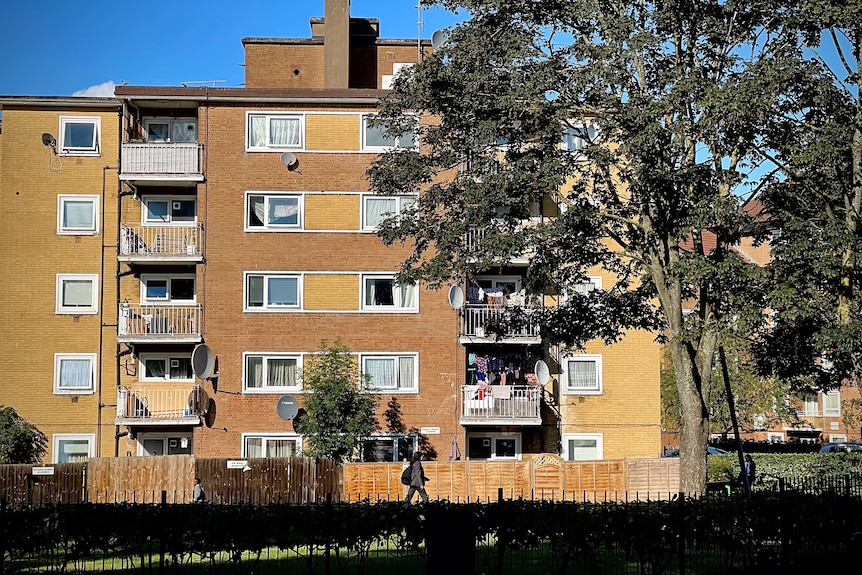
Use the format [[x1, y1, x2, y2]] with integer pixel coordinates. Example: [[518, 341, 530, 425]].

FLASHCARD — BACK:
[[0, 0, 660, 461]]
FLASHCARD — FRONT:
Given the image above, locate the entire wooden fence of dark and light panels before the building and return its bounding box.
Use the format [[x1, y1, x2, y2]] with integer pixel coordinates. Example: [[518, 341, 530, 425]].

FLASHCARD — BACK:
[[0, 454, 679, 503]]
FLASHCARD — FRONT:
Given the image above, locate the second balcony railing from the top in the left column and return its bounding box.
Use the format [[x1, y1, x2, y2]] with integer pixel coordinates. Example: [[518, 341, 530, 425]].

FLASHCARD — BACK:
[[117, 224, 203, 264]]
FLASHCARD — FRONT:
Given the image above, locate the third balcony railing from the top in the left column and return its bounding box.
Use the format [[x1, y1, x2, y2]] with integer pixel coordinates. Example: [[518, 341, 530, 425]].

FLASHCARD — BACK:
[[117, 303, 203, 343]]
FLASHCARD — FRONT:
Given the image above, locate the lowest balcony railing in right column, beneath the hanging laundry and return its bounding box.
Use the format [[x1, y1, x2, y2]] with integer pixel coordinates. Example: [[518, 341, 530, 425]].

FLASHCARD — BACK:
[[461, 384, 542, 425]]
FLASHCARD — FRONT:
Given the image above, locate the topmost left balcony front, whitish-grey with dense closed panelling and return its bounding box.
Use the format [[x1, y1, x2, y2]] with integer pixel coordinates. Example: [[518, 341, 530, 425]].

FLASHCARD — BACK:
[[120, 142, 204, 183]]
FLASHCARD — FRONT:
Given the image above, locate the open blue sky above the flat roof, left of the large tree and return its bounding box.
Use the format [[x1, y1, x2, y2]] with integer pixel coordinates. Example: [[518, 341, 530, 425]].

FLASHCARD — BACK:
[[0, 0, 461, 96]]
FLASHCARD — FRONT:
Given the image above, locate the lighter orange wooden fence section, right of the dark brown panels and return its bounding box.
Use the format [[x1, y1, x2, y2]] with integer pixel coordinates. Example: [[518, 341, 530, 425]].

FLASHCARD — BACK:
[[343, 454, 679, 501]]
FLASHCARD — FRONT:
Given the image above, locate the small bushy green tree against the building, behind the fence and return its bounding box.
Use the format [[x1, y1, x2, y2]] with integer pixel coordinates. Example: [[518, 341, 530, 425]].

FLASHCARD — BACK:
[[297, 339, 377, 462]]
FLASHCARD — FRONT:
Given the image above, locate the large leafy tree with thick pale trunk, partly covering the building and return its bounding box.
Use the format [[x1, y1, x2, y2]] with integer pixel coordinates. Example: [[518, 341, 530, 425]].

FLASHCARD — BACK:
[[368, 0, 817, 492]]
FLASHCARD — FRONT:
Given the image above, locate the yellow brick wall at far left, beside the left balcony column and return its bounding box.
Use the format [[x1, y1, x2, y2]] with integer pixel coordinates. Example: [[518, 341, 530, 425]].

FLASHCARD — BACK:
[[0, 106, 118, 461]]
